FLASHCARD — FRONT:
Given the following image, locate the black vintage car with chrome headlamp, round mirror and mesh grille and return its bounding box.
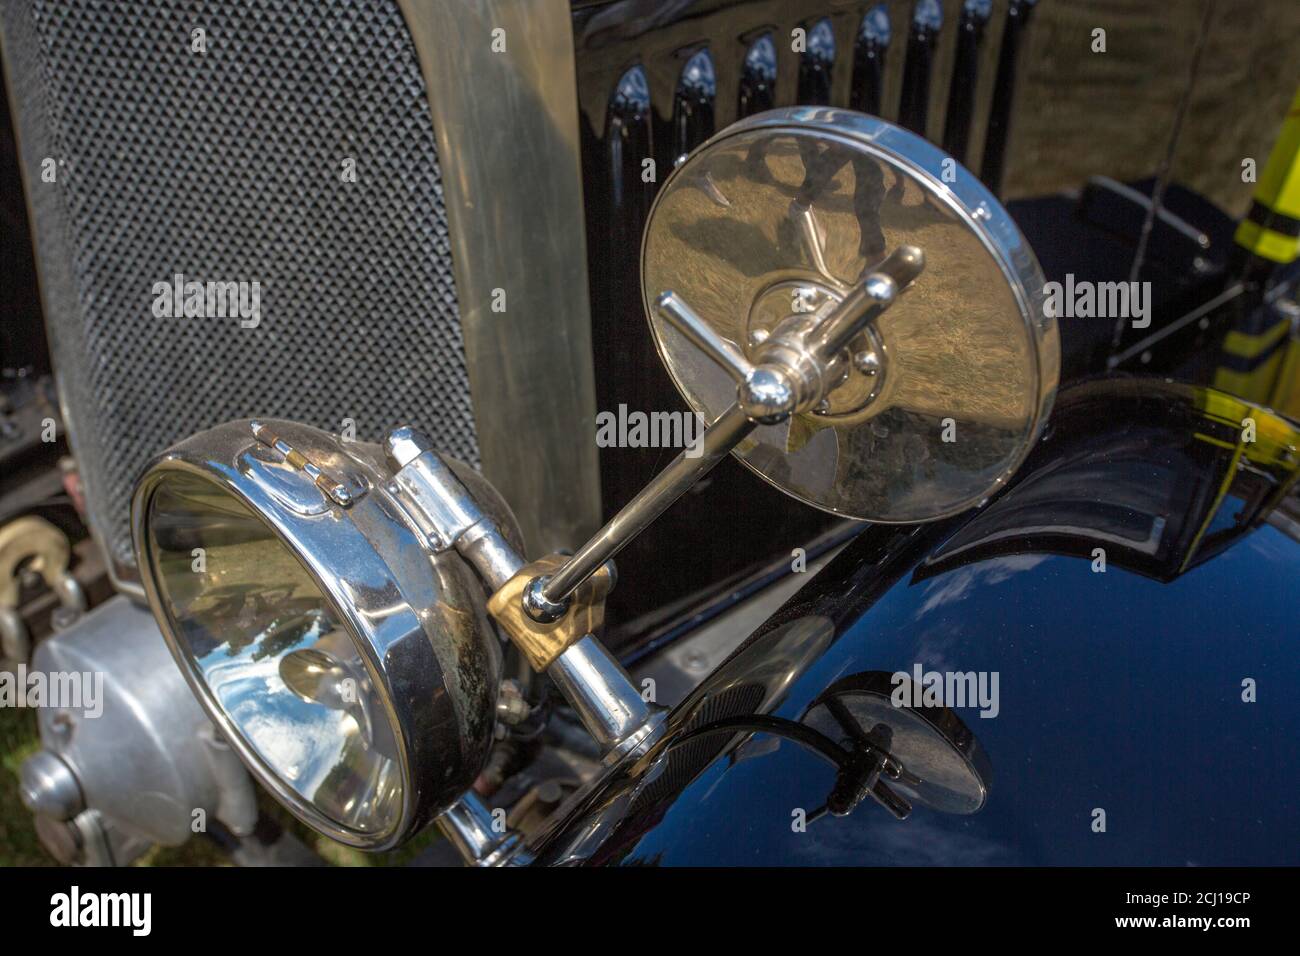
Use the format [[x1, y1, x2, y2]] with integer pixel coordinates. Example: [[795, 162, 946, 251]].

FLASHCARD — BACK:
[[0, 0, 1300, 866]]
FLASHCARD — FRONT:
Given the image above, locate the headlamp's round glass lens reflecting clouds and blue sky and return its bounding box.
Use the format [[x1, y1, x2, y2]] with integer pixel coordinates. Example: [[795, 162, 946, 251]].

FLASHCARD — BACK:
[[147, 473, 402, 832]]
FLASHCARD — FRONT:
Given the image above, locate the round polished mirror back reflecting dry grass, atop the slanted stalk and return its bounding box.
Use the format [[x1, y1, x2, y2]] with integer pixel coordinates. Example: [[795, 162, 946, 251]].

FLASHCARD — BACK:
[[641, 107, 1060, 522]]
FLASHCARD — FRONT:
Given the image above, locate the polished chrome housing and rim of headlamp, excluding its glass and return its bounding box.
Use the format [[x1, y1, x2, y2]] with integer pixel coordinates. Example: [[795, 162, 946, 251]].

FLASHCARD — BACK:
[[131, 421, 515, 851]]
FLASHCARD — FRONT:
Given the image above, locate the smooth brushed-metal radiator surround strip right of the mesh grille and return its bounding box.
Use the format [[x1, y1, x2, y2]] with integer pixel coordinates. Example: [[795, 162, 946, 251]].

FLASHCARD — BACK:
[[398, 0, 601, 554]]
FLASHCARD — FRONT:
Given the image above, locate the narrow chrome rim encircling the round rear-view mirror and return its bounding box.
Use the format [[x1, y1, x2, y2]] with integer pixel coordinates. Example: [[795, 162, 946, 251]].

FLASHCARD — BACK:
[[641, 107, 1060, 524]]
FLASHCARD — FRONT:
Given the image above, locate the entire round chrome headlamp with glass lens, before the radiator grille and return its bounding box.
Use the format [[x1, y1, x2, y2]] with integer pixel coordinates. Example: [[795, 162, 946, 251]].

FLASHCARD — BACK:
[[131, 421, 517, 849]]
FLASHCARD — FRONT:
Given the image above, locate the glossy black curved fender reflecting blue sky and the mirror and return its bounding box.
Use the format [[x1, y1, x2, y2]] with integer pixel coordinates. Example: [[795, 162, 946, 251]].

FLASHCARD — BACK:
[[542, 378, 1300, 866]]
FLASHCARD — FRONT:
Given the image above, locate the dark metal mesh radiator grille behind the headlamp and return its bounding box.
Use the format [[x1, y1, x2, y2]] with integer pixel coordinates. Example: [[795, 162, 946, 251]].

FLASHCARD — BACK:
[[3, 0, 477, 564]]
